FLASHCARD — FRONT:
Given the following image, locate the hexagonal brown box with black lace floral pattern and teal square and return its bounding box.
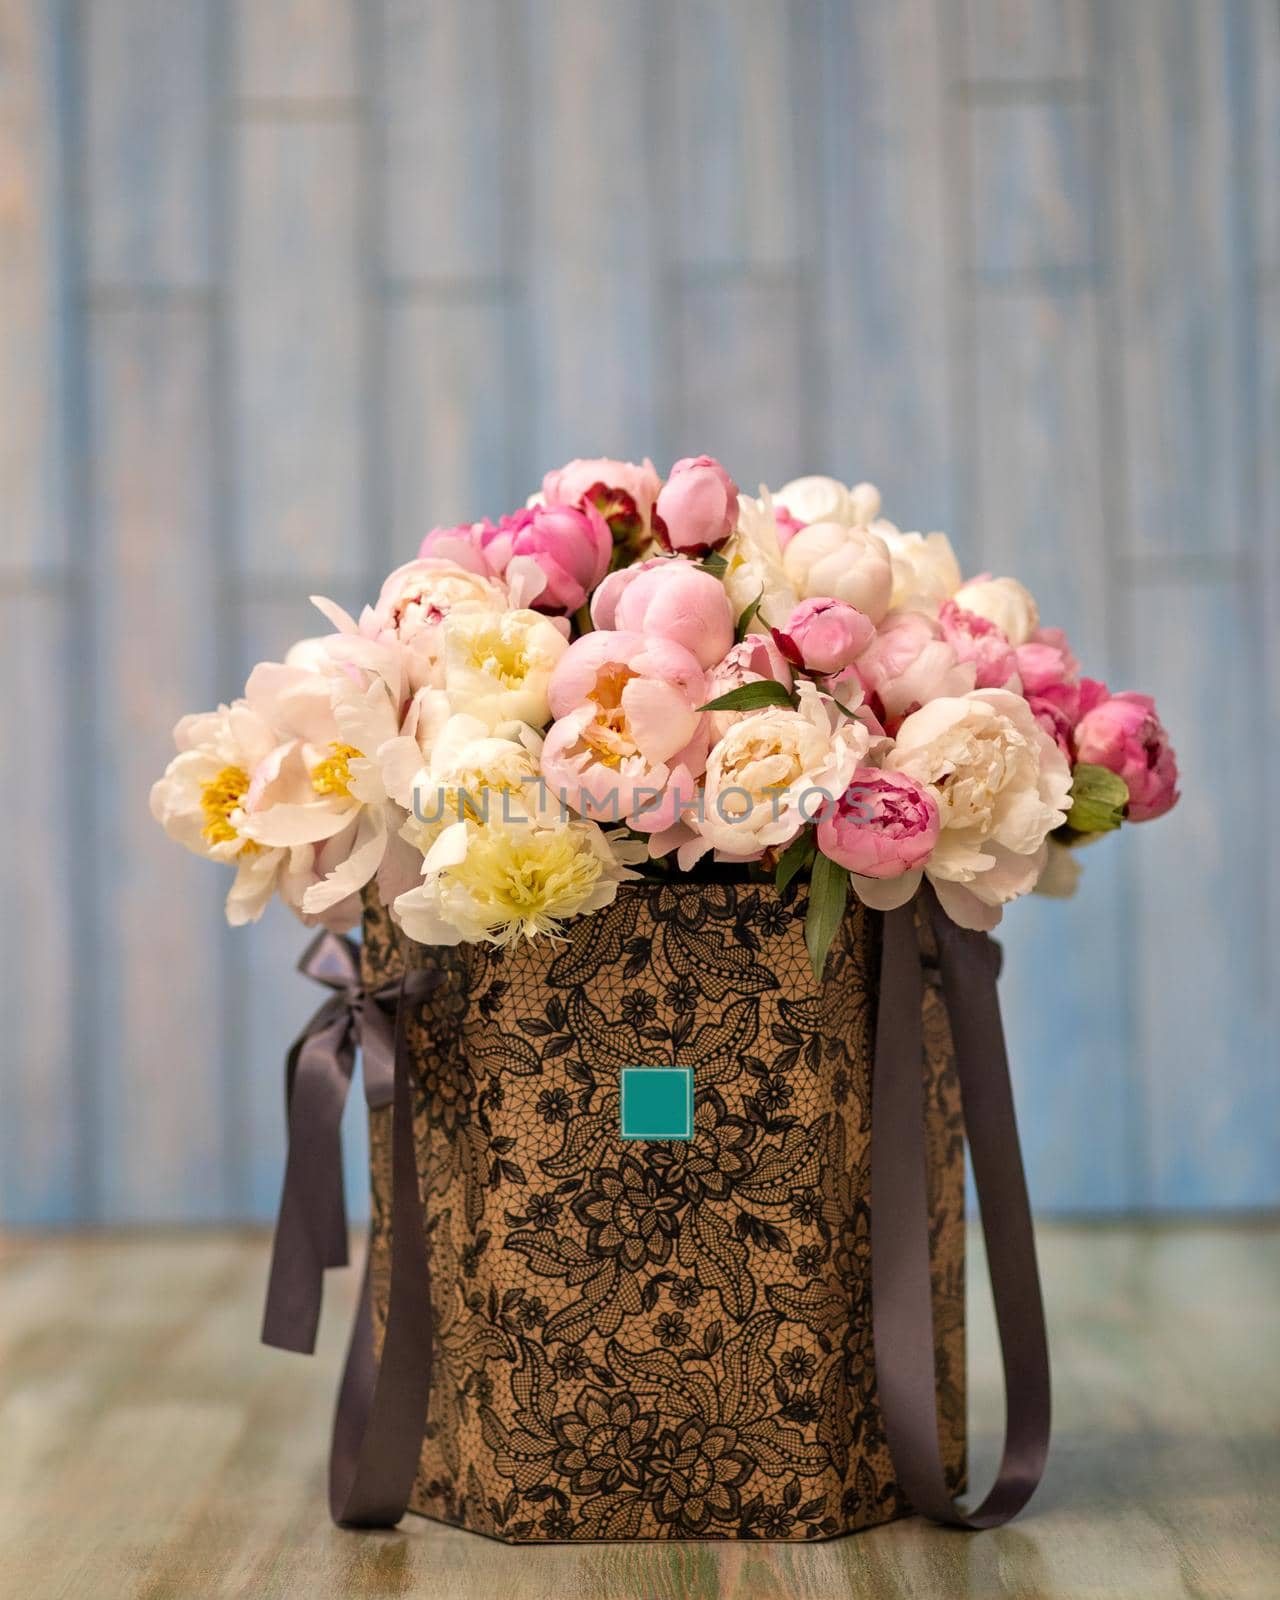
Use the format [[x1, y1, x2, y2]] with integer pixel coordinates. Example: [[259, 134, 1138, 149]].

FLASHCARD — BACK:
[[362, 882, 965, 1542]]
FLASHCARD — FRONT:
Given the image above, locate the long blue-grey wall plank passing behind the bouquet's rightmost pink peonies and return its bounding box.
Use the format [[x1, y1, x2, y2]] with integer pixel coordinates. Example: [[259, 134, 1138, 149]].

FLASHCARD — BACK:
[[974, 294, 1134, 1211]]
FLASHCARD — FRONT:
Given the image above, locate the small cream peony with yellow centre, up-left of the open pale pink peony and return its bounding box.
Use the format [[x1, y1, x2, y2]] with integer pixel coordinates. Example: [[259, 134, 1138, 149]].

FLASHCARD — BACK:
[[443, 611, 570, 733]]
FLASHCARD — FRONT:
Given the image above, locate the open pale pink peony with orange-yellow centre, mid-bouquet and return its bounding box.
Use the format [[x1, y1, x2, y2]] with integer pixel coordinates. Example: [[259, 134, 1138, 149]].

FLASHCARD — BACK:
[[542, 632, 707, 832]]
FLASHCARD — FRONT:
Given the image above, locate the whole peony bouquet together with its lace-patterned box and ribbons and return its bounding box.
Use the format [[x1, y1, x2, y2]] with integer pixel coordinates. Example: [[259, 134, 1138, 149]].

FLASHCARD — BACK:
[[152, 456, 1178, 1541]]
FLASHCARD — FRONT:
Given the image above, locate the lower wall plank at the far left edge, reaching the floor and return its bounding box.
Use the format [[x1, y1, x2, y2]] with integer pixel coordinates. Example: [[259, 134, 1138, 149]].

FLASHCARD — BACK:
[[0, 589, 80, 1227]]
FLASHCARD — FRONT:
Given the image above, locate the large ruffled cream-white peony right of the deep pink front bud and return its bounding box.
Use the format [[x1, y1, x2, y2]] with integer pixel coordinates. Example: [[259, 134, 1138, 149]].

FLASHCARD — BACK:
[[864, 690, 1070, 928]]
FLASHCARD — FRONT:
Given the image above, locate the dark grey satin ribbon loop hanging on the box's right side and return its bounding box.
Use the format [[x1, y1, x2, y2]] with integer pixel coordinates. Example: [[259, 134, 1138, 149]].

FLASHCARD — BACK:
[[870, 886, 1050, 1530]]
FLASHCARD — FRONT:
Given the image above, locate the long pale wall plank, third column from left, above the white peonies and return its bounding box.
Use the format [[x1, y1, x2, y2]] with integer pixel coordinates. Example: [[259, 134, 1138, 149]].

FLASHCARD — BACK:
[[230, 118, 366, 581]]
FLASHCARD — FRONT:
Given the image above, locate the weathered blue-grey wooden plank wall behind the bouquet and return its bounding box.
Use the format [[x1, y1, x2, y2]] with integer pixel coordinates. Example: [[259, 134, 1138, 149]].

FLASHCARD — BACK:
[[0, 0, 1280, 1224]]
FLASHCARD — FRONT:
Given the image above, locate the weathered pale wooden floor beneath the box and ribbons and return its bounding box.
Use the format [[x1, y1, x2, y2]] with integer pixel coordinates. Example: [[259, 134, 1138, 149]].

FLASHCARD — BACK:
[[0, 1224, 1280, 1600]]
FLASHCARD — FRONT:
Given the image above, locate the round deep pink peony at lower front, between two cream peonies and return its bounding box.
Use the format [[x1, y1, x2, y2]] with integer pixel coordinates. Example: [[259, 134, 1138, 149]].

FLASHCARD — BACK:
[[818, 766, 939, 878]]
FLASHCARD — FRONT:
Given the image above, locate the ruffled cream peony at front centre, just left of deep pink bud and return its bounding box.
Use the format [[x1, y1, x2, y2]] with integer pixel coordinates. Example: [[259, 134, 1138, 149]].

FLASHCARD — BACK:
[[678, 680, 870, 867]]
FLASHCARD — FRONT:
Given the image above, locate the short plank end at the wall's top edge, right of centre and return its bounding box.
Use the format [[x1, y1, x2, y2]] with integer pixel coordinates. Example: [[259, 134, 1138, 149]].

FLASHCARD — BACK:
[[965, 0, 1093, 85]]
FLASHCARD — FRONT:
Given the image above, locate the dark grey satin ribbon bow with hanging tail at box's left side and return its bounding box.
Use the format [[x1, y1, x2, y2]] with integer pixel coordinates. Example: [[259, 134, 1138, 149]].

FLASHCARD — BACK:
[[262, 933, 440, 1355]]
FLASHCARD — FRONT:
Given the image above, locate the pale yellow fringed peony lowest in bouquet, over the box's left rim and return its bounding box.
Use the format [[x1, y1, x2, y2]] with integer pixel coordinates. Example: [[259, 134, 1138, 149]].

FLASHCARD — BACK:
[[395, 818, 643, 944]]
